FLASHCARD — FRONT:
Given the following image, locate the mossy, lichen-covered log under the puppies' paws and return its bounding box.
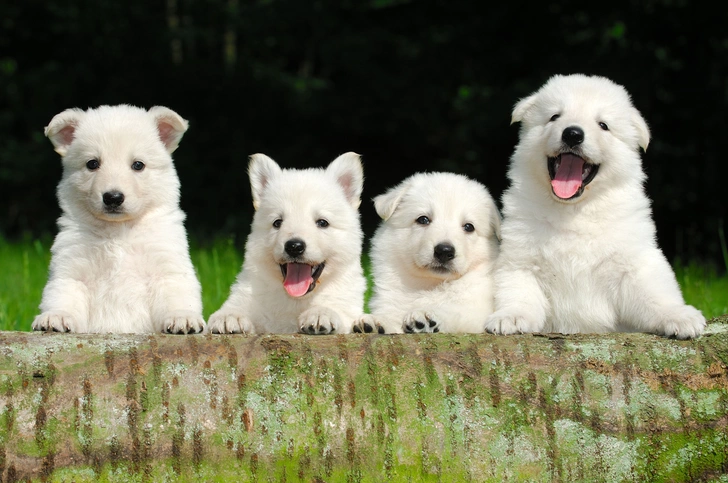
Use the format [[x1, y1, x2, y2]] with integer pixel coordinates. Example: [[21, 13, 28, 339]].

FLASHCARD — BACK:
[[0, 316, 728, 483]]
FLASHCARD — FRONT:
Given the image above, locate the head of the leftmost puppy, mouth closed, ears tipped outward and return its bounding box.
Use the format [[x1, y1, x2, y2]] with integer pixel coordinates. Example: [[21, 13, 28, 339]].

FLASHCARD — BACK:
[[45, 105, 188, 223]]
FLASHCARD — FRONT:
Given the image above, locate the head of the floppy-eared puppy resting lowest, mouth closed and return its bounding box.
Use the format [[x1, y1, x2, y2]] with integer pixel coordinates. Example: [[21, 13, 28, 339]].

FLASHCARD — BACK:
[[374, 173, 500, 281]]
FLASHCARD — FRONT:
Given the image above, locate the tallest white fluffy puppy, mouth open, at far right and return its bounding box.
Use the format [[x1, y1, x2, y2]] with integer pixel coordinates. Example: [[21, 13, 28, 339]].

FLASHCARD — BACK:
[[485, 75, 705, 338]]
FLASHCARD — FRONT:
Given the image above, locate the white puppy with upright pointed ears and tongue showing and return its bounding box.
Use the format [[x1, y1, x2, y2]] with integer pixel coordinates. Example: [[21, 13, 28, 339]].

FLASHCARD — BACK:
[[208, 153, 366, 334]]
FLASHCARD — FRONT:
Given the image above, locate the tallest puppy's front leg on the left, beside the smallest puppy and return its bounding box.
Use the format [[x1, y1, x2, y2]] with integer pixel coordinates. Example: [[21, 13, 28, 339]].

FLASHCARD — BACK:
[[484, 270, 548, 335]]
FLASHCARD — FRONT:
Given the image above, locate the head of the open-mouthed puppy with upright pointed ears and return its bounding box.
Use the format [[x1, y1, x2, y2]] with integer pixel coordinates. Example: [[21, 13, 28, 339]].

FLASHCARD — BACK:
[[248, 153, 364, 297]]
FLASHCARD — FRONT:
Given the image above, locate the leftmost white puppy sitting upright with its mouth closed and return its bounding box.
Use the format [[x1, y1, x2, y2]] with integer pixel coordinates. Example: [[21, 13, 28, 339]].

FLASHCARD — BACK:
[[33, 105, 205, 334]]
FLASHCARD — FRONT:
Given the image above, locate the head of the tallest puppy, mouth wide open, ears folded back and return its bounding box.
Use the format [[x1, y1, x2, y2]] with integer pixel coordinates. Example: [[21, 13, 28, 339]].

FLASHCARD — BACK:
[[509, 74, 650, 203]]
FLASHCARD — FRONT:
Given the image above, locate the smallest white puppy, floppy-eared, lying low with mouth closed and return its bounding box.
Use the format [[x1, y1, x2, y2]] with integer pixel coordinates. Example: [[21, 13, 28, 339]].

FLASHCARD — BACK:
[[354, 173, 500, 333]]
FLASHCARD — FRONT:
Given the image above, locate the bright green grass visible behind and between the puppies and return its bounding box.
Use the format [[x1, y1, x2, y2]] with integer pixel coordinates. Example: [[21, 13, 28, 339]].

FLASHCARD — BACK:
[[0, 237, 728, 330]]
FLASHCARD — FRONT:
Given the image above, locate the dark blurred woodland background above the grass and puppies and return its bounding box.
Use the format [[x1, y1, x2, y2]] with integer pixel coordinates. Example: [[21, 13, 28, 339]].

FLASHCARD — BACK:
[[0, 0, 728, 267]]
